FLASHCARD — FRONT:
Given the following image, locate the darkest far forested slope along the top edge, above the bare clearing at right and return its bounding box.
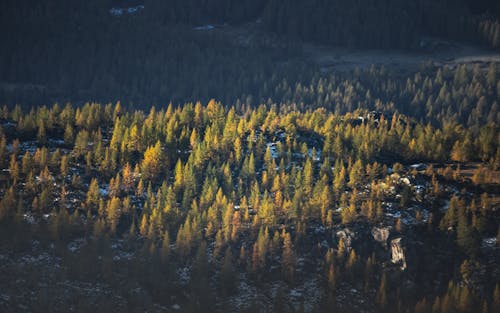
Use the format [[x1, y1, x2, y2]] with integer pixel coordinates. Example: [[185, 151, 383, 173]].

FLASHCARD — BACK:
[[2, 0, 500, 48]]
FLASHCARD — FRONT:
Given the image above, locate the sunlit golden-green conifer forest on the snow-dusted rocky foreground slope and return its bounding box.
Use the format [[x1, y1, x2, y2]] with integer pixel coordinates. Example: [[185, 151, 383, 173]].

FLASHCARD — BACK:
[[0, 101, 500, 312]]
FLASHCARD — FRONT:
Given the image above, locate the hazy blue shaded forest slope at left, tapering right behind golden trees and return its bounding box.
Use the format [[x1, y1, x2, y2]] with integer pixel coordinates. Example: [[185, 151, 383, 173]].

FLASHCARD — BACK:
[[0, 1, 311, 107]]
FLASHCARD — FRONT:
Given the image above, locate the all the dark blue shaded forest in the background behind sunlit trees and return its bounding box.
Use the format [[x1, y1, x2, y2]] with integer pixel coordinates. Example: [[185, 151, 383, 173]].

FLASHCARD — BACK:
[[0, 1, 500, 109]]
